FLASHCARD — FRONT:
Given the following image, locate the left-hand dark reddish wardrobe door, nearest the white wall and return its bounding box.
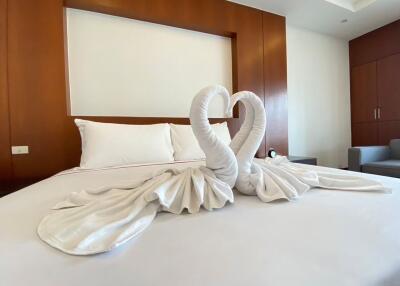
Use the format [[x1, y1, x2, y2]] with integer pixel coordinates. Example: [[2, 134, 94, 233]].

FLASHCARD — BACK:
[[351, 62, 378, 123]]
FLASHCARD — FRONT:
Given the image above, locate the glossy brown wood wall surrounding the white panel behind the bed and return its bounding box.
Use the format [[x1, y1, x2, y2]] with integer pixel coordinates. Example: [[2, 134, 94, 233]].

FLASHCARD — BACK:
[[0, 0, 288, 190]]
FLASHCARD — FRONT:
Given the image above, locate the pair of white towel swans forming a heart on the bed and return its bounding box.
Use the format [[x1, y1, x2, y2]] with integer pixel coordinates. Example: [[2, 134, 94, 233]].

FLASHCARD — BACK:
[[38, 86, 386, 255]]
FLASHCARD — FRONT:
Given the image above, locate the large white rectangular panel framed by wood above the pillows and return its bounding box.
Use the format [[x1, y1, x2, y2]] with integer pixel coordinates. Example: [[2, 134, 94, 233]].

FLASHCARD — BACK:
[[67, 8, 232, 118]]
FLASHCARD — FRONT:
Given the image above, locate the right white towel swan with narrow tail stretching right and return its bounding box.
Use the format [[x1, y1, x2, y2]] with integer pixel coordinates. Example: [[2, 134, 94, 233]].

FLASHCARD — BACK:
[[230, 91, 390, 202]]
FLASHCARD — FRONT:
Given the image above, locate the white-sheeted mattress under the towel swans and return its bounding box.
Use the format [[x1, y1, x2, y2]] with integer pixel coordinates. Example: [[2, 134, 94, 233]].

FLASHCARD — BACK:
[[0, 162, 400, 286]]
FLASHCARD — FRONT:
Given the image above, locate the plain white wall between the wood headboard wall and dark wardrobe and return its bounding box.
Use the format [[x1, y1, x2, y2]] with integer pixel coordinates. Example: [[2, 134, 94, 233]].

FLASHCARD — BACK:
[[287, 25, 351, 167]]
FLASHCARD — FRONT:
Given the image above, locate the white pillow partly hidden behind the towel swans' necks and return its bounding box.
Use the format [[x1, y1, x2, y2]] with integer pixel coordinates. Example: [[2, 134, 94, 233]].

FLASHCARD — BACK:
[[171, 122, 231, 161]]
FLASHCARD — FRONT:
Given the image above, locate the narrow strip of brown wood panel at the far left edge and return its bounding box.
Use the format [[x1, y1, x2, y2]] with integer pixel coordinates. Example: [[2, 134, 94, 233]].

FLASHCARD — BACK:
[[0, 0, 12, 182]]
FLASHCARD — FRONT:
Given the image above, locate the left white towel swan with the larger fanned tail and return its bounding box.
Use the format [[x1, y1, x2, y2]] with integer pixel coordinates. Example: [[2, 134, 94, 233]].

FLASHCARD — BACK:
[[37, 86, 238, 255]]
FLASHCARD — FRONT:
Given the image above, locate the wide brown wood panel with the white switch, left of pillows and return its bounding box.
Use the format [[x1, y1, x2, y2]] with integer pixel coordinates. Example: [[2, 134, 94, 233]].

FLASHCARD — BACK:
[[8, 0, 67, 179]]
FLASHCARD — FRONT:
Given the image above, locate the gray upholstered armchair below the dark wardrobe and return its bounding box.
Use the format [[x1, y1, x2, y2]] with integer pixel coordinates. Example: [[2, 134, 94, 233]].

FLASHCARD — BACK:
[[349, 139, 400, 178]]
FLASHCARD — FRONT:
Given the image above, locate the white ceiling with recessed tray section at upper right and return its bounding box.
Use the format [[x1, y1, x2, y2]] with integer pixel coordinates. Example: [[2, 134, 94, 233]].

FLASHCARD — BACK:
[[230, 0, 400, 40]]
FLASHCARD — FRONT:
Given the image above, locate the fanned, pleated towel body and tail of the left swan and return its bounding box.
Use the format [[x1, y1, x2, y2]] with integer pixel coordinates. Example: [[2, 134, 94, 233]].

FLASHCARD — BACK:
[[38, 168, 233, 255]]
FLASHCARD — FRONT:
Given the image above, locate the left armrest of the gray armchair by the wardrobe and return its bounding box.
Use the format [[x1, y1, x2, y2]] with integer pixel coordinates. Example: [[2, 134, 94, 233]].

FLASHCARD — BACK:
[[349, 146, 390, 172]]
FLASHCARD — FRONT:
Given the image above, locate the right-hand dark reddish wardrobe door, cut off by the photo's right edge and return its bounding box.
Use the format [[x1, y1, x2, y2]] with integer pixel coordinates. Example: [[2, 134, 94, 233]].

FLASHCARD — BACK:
[[378, 54, 400, 120]]
